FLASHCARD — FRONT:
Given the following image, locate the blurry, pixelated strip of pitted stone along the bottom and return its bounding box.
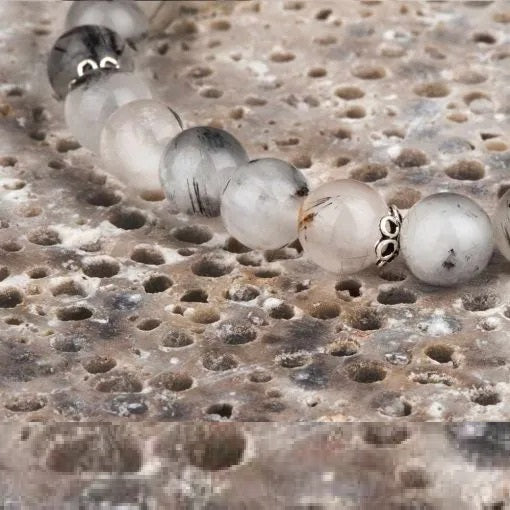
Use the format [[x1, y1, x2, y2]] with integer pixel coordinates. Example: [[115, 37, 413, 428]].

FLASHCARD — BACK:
[[0, 423, 510, 510]]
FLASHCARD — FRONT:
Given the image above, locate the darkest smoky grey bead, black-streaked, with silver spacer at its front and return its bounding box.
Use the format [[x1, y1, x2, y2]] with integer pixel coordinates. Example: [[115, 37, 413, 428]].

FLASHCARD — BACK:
[[47, 25, 134, 99]]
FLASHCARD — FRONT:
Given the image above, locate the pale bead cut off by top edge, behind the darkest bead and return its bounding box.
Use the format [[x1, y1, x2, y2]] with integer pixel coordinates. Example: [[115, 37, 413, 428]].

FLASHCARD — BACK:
[[66, 0, 149, 41]]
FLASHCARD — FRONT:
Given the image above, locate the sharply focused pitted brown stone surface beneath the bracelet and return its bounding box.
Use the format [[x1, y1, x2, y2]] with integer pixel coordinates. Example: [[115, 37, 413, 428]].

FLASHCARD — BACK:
[[0, 0, 510, 422]]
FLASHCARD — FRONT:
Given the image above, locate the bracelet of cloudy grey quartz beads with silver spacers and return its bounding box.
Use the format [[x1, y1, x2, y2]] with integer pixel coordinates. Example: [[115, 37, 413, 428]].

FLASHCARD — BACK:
[[48, 1, 510, 286]]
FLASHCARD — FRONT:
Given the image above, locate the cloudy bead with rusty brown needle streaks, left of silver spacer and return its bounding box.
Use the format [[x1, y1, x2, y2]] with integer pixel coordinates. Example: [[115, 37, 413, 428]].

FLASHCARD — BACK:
[[299, 179, 388, 275]]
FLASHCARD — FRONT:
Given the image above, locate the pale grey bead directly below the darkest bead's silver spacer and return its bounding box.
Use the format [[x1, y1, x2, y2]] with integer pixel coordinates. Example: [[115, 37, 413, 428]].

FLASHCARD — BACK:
[[65, 69, 152, 153]]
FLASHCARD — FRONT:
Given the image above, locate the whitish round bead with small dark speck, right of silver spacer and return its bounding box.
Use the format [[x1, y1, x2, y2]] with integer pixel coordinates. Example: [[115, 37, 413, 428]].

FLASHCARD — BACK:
[[400, 193, 494, 286]]
